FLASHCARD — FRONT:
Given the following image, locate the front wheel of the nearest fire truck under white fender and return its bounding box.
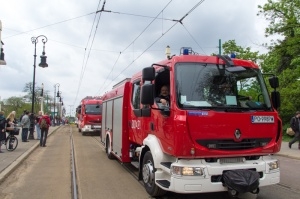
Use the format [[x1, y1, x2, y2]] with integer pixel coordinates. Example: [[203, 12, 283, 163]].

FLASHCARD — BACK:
[[142, 151, 167, 197]]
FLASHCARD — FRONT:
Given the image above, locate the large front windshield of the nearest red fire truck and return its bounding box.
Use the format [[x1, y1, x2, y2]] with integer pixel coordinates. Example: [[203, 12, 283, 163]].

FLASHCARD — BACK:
[[175, 63, 271, 110]]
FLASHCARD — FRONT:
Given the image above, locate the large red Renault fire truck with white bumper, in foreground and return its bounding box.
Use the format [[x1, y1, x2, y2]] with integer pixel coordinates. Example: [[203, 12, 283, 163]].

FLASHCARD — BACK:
[[101, 48, 282, 196]]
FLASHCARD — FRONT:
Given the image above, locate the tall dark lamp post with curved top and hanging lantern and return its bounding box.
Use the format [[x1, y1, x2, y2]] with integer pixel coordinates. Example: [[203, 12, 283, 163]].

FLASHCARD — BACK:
[[28, 35, 48, 139]]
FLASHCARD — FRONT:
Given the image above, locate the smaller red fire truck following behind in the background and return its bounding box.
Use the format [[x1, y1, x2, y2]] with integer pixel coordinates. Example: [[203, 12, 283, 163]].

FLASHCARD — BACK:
[[76, 96, 102, 135]]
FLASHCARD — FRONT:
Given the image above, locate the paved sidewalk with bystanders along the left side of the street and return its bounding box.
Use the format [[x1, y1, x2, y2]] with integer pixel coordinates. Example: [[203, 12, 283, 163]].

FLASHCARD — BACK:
[[0, 126, 60, 183]]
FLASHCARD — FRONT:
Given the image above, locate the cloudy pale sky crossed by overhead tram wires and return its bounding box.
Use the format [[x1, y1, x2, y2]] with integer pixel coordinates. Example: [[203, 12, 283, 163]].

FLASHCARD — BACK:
[[0, 0, 269, 115]]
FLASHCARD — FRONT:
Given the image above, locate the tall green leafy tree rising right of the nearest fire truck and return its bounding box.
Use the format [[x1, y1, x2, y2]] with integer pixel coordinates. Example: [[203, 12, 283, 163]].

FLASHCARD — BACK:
[[258, 0, 300, 124]]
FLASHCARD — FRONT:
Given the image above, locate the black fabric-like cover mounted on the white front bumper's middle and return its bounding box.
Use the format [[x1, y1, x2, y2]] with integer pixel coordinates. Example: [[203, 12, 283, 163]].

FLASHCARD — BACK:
[[222, 169, 259, 193]]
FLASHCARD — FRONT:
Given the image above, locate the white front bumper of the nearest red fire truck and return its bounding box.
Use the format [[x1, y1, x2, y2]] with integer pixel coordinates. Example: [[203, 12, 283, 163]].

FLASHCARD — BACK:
[[155, 156, 280, 193]]
